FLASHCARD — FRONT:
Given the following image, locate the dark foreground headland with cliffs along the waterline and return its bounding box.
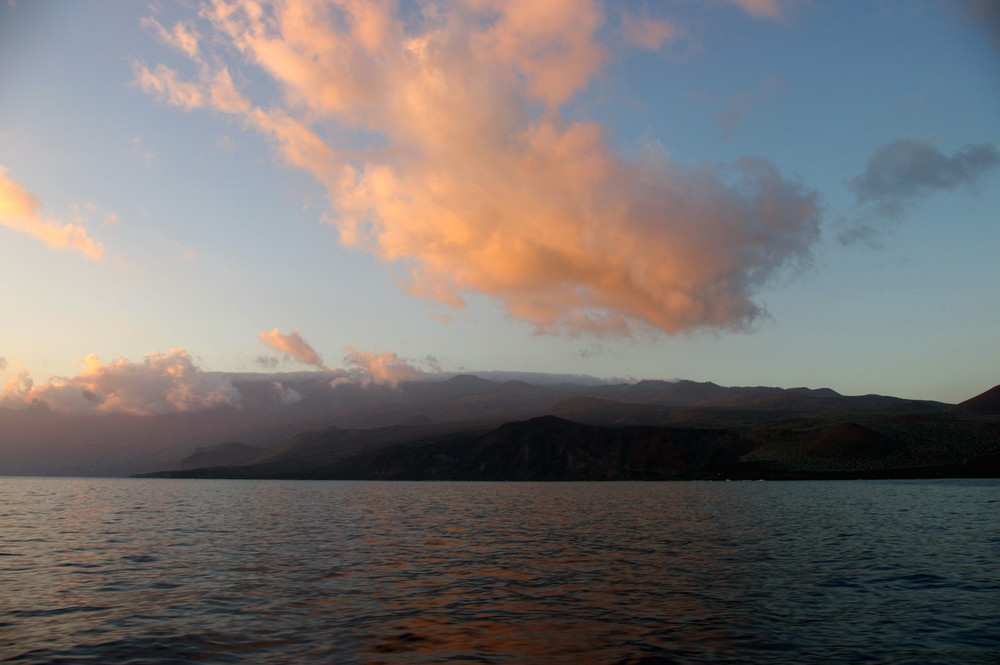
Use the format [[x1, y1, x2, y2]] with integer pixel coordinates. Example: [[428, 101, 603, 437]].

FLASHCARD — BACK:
[[146, 414, 1000, 481]]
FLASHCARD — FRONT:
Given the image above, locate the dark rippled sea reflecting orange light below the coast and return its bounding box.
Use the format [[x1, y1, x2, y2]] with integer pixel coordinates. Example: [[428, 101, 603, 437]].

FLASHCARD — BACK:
[[0, 478, 1000, 665]]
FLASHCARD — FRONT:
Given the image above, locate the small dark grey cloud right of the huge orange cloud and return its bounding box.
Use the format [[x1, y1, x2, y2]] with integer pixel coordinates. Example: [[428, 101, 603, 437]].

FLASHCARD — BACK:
[[849, 139, 1000, 216]]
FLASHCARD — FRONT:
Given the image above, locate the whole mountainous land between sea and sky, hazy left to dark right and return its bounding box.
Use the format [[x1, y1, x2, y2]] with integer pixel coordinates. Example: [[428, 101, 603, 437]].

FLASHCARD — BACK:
[[0, 372, 997, 479]]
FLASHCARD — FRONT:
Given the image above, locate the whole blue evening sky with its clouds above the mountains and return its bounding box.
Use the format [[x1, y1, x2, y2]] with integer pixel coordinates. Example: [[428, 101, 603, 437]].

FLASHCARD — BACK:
[[0, 0, 1000, 413]]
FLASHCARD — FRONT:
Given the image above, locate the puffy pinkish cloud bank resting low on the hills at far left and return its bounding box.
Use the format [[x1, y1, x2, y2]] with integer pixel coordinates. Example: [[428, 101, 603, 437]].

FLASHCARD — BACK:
[[0, 349, 241, 415]]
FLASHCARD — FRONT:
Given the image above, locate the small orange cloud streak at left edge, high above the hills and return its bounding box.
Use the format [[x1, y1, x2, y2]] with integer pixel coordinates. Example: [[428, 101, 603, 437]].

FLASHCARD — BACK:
[[0, 165, 104, 260]]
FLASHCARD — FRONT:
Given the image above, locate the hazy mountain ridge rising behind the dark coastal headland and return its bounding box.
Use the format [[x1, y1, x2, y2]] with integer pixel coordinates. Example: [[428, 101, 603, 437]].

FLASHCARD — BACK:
[[0, 372, 993, 476]]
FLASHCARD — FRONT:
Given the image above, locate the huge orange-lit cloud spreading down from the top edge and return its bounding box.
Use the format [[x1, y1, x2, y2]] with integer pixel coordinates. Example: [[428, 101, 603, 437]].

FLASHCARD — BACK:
[[136, 0, 819, 335]]
